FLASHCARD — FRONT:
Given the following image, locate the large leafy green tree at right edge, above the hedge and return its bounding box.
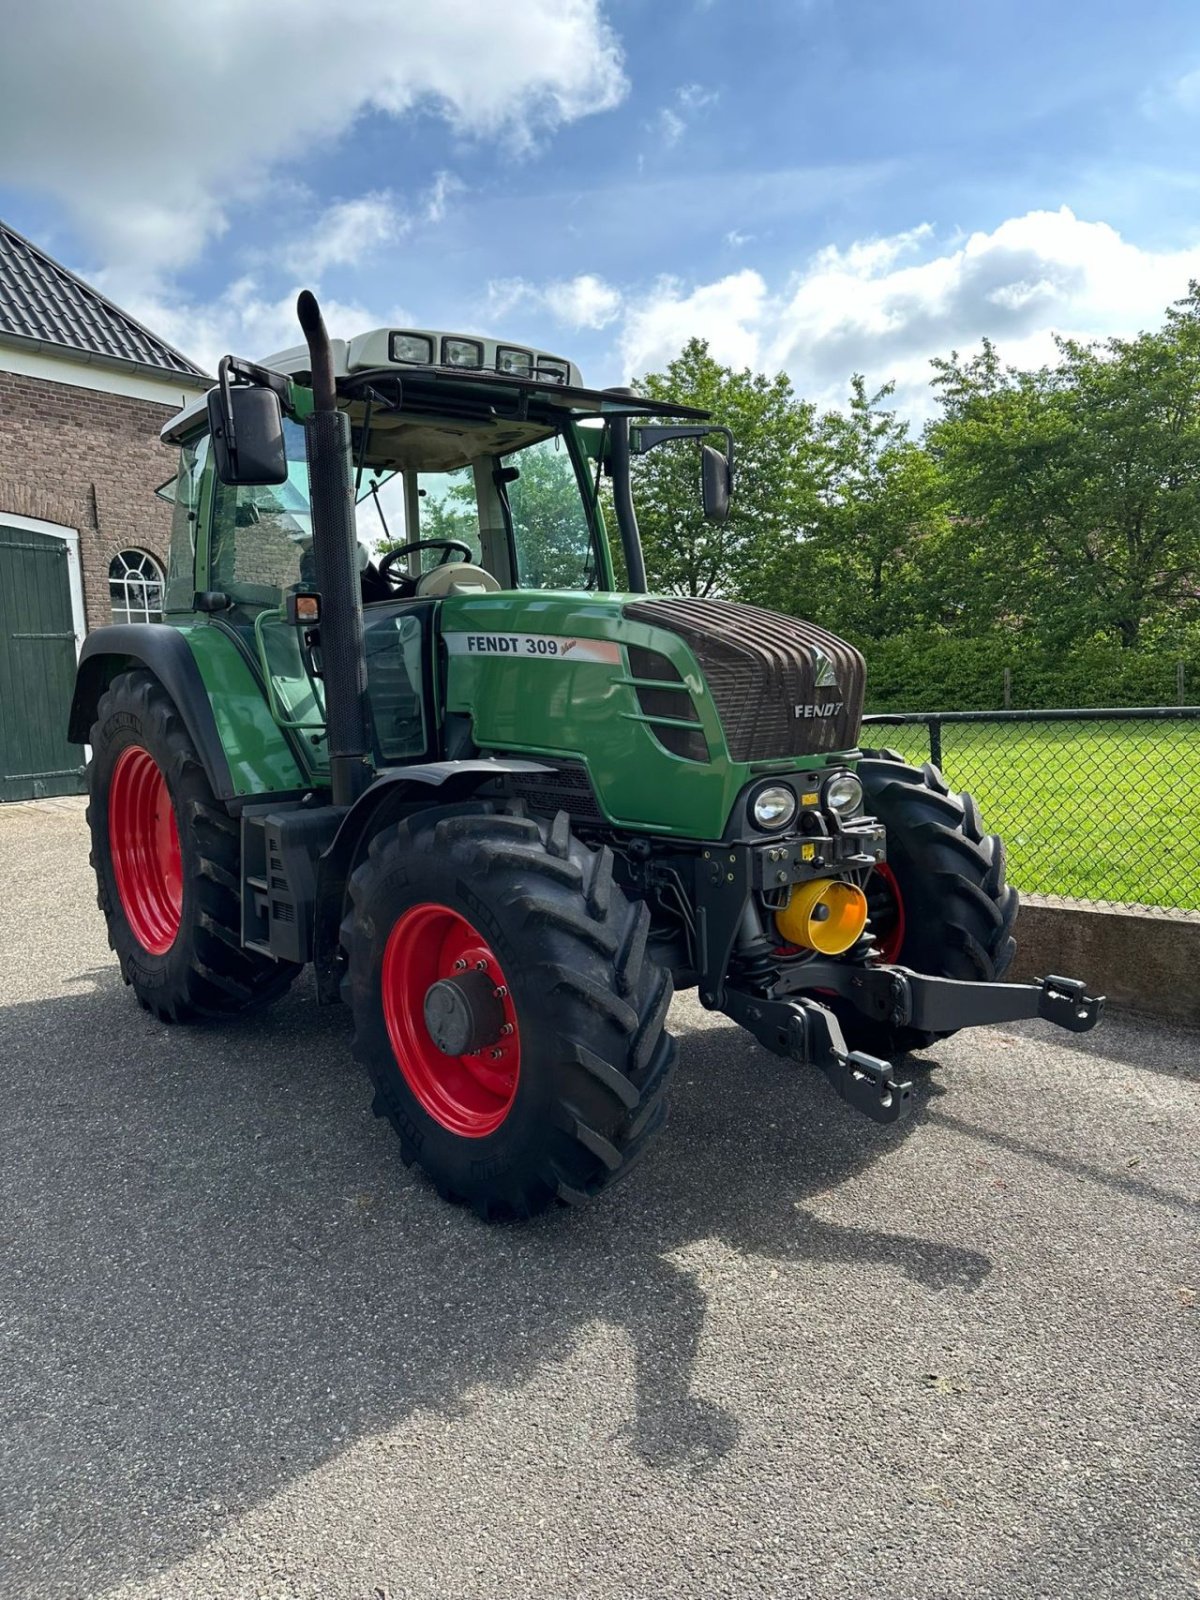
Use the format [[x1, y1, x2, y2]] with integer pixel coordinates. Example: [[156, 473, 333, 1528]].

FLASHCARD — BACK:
[[928, 283, 1200, 650]]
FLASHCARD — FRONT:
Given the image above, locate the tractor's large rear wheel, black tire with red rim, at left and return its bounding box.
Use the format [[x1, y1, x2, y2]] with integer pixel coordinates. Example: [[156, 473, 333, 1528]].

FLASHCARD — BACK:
[[88, 670, 299, 1022]]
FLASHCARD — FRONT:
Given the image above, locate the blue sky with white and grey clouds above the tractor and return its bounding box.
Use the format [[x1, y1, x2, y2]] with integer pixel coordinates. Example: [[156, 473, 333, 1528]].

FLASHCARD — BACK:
[[0, 0, 1200, 421]]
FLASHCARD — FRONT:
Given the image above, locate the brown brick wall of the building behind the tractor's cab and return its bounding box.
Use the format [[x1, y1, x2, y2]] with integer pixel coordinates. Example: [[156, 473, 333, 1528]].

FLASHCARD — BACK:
[[0, 371, 178, 629]]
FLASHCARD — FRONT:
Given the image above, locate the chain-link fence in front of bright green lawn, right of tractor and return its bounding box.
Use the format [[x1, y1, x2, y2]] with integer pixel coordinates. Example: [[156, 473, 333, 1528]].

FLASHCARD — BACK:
[[862, 706, 1200, 920]]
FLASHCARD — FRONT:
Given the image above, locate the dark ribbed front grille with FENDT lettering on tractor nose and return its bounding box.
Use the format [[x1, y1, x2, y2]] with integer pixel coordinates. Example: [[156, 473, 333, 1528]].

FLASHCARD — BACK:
[[624, 600, 866, 762]]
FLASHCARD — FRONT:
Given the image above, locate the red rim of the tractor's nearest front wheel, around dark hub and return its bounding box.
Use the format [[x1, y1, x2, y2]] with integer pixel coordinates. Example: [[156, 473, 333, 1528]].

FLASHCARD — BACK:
[[382, 902, 520, 1139]]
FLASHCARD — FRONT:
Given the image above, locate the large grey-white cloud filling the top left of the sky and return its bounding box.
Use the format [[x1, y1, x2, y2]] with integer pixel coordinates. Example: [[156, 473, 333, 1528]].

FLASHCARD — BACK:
[[0, 0, 627, 282]]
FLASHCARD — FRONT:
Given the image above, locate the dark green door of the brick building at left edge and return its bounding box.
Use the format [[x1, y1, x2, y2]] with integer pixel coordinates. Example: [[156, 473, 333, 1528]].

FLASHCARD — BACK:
[[0, 515, 83, 800]]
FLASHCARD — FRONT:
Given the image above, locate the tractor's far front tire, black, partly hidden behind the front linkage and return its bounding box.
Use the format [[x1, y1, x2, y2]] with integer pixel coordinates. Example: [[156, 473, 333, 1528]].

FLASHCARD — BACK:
[[837, 750, 1018, 1058]]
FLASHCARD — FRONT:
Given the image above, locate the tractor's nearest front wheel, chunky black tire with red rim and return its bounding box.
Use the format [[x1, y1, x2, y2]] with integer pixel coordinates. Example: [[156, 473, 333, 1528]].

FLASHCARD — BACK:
[[341, 803, 675, 1219]]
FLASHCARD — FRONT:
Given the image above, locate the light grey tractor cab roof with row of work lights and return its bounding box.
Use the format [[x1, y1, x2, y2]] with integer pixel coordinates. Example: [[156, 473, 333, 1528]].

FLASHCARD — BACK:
[[162, 328, 709, 443]]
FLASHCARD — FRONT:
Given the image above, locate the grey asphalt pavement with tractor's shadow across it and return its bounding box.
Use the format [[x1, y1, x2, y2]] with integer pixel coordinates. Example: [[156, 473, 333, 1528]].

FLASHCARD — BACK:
[[0, 802, 1200, 1600]]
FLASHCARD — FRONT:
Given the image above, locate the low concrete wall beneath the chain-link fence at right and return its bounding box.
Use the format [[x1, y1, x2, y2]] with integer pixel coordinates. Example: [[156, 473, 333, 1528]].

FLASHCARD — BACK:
[[1008, 894, 1200, 1027]]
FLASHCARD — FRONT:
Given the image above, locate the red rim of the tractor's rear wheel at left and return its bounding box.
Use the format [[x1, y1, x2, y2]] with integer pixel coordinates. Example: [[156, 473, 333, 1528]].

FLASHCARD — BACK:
[[109, 744, 184, 955]]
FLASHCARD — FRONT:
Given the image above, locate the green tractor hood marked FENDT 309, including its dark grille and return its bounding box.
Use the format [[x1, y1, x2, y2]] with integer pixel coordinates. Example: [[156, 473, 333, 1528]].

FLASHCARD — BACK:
[[438, 592, 866, 837]]
